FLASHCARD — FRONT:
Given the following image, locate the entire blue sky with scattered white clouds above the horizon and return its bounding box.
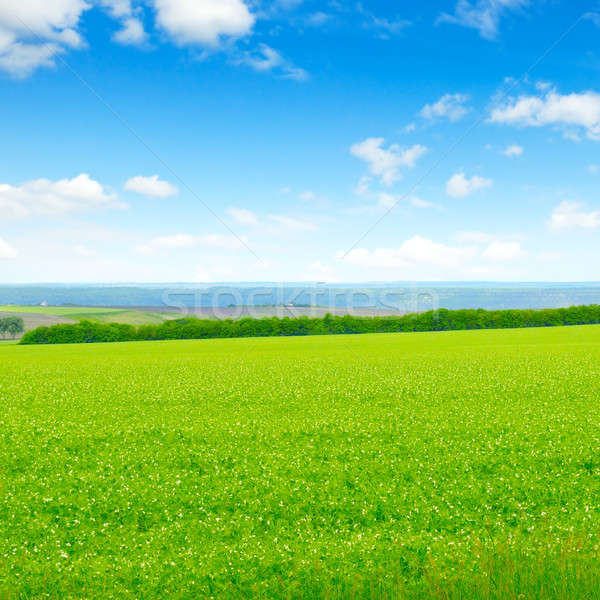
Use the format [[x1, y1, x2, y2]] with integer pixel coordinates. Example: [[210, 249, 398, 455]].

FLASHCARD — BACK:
[[0, 0, 600, 282]]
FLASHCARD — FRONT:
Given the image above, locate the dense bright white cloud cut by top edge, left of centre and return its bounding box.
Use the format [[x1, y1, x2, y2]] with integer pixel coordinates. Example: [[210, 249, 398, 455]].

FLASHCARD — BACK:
[[154, 0, 255, 48]]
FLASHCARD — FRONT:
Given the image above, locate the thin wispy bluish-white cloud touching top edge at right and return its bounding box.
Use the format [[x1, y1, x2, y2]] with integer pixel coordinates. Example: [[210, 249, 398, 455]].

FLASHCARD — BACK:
[[438, 0, 529, 40]]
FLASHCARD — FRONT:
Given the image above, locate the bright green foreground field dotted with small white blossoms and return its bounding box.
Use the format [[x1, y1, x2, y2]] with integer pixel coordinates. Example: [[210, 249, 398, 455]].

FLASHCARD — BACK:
[[0, 326, 600, 600]]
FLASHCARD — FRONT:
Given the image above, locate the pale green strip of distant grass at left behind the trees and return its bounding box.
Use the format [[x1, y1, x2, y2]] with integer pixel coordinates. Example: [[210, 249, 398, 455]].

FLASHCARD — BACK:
[[0, 304, 173, 325]]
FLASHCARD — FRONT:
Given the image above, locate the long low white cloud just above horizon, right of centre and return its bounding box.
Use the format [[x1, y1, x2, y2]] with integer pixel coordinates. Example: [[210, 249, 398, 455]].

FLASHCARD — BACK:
[[337, 235, 474, 268]]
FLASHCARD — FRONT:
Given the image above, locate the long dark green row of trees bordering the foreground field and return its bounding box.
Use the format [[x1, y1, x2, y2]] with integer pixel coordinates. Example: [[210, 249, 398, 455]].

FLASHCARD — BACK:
[[21, 304, 600, 344]]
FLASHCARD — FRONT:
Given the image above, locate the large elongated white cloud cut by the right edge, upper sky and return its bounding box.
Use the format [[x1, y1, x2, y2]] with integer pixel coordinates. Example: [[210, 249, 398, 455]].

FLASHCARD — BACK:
[[489, 91, 600, 140]]
